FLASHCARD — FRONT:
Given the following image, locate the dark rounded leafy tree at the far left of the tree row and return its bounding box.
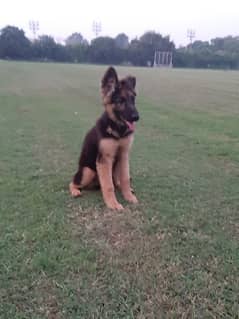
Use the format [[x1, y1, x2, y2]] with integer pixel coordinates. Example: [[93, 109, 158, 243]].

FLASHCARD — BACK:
[[0, 26, 31, 60]]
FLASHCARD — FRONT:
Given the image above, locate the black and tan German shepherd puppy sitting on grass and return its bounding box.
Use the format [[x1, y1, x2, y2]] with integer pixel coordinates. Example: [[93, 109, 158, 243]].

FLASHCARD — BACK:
[[69, 67, 139, 210]]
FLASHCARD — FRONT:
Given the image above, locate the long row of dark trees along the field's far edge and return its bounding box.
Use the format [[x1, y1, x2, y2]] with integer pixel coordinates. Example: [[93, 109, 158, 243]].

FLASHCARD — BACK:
[[0, 26, 239, 69]]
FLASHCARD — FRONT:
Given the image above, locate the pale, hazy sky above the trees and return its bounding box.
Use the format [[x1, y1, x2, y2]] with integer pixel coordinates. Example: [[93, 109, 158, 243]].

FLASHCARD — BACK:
[[0, 0, 239, 46]]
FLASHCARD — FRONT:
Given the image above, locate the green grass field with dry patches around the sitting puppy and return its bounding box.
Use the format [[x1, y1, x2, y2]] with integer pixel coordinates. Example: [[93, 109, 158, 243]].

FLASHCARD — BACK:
[[0, 61, 239, 319]]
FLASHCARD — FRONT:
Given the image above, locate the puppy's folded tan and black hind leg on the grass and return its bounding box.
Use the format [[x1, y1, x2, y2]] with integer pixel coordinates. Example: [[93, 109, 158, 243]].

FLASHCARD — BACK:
[[69, 167, 96, 197]]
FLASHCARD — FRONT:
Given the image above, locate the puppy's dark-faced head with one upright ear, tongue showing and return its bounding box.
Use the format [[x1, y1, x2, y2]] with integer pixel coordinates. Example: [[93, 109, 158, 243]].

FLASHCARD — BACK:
[[101, 67, 139, 129]]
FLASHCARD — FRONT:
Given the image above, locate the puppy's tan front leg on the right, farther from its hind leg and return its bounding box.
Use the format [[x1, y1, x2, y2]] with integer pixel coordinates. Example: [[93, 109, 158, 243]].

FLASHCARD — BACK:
[[118, 152, 138, 204]]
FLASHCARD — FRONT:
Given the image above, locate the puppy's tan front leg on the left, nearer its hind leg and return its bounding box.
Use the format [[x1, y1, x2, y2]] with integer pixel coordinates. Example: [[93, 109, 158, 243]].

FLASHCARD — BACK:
[[96, 154, 123, 210]]
